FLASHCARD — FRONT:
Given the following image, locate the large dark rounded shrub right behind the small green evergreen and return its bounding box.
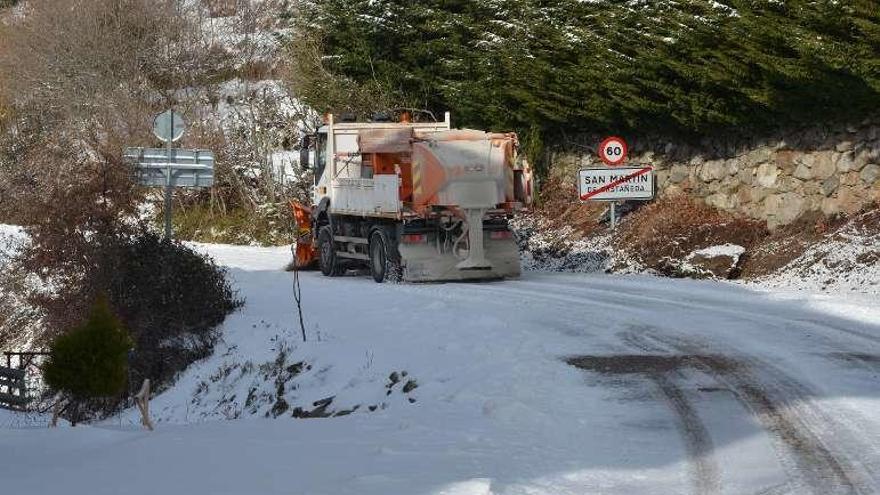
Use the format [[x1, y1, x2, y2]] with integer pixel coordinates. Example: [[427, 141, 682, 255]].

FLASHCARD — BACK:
[[93, 233, 241, 394]]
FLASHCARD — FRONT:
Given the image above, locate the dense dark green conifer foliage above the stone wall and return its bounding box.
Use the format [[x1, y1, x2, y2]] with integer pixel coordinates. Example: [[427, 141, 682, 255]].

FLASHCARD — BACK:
[[292, 0, 880, 140]]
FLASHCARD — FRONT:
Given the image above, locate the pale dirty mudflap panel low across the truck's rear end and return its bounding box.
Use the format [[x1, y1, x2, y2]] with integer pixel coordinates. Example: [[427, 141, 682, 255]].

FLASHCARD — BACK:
[[398, 237, 520, 282]]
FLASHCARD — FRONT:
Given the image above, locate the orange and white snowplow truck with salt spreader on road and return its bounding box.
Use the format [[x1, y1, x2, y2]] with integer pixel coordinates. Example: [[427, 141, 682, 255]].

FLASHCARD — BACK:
[[291, 113, 532, 282]]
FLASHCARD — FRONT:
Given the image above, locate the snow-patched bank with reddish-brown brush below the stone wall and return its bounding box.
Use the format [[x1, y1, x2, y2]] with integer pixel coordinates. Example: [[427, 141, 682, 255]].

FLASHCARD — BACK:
[[513, 204, 880, 296]]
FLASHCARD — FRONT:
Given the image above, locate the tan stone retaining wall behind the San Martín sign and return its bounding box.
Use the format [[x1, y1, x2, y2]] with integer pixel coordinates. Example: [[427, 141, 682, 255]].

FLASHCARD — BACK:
[[551, 120, 880, 228]]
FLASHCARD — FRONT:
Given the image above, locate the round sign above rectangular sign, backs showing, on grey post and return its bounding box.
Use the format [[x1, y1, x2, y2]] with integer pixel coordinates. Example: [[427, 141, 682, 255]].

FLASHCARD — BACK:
[[123, 109, 214, 239]]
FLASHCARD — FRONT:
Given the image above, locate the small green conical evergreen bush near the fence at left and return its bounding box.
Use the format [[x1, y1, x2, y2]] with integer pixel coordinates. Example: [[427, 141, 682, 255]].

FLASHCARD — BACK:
[[43, 297, 132, 421]]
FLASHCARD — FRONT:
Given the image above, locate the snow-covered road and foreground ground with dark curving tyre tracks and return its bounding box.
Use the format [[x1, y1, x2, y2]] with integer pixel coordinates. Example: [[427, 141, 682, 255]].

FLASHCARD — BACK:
[[0, 246, 880, 495]]
